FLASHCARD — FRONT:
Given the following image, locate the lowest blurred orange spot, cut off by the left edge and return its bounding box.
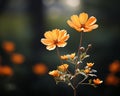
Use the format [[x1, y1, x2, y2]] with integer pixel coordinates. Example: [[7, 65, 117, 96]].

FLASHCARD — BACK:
[[0, 66, 13, 76]]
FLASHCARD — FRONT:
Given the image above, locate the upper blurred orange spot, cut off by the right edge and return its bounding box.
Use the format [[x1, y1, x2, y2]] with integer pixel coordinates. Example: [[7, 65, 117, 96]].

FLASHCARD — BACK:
[[109, 60, 120, 73]]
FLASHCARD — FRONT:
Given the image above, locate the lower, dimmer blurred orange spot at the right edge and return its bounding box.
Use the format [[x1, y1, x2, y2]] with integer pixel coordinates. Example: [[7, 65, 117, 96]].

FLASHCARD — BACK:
[[105, 75, 120, 86]]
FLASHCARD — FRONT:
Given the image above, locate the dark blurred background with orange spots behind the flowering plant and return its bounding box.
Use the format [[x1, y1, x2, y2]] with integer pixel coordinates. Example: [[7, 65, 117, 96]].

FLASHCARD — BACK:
[[0, 0, 120, 96]]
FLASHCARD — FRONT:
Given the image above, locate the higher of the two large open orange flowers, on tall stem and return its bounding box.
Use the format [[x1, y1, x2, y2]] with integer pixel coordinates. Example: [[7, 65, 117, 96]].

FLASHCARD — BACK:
[[67, 13, 98, 32]]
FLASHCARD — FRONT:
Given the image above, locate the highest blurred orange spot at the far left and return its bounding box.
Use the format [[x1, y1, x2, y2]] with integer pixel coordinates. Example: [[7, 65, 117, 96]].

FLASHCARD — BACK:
[[2, 41, 15, 53]]
